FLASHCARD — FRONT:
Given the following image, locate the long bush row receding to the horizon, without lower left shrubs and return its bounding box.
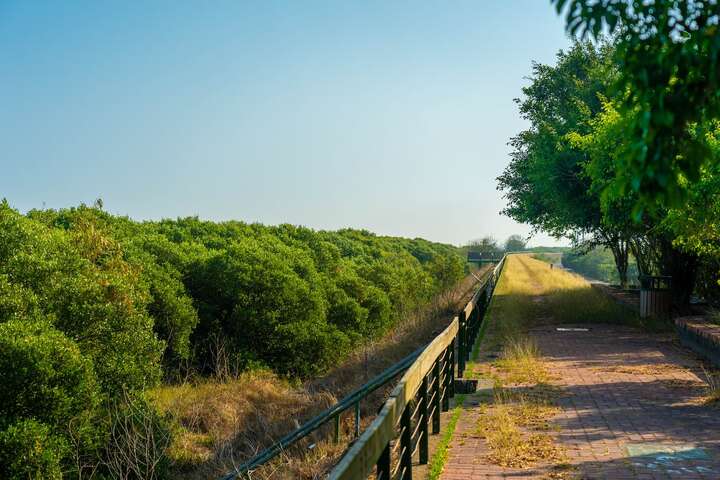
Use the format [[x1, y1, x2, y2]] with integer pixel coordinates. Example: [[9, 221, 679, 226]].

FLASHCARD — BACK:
[[7, 203, 464, 380]]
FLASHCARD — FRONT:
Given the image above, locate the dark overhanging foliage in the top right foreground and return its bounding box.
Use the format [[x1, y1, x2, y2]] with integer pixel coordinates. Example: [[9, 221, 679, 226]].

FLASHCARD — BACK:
[[552, 0, 720, 211]]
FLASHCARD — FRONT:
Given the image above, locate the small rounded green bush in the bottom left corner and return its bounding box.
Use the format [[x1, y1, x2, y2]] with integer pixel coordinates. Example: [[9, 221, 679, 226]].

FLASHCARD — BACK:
[[0, 419, 67, 480]]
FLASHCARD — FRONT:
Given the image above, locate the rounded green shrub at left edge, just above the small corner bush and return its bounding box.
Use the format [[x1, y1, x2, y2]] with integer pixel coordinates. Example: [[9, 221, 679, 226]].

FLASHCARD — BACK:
[[0, 320, 101, 478]]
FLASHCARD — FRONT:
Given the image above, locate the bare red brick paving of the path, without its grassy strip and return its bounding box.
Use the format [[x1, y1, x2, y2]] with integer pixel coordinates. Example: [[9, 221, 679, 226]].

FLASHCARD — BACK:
[[442, 325, 720, 480]]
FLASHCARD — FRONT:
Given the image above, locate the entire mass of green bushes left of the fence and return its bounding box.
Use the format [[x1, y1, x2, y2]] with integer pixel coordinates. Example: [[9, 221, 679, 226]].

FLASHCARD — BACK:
[[0, 201, 465, 479]]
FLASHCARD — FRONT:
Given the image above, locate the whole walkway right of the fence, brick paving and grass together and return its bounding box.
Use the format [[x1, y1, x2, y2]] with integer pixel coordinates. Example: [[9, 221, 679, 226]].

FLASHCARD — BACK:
[[441, 255, 720, 480]]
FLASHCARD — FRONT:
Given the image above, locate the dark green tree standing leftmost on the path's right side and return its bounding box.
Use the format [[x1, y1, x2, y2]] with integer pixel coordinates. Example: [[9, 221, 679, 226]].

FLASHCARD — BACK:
[[498, 42, 635, 285]]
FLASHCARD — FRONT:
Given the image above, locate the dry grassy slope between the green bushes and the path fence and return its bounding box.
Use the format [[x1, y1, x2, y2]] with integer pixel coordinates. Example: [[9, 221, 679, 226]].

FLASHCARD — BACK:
[[151, 272, 490, 480]]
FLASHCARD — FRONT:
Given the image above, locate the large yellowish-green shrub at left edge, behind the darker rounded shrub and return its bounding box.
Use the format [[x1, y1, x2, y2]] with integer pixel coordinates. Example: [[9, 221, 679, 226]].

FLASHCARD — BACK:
[[0, 204, 163, 395]]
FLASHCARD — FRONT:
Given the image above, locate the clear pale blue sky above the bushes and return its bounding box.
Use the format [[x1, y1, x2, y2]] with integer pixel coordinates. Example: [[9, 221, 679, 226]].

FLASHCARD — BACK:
[[0, 0, 569, 248]]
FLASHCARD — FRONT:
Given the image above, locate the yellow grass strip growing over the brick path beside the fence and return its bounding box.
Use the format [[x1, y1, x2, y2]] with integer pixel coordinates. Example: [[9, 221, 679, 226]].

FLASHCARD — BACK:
[[467, 255, 637, 477]]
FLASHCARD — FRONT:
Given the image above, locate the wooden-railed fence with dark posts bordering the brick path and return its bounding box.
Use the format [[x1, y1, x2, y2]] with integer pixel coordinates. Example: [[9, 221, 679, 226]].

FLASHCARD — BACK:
[[329, 257, 505, 480]]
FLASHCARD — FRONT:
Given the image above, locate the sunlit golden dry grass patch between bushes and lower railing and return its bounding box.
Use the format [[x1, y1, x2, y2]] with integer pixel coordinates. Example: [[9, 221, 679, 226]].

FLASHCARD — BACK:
[[150, 371, 335, 479]]
